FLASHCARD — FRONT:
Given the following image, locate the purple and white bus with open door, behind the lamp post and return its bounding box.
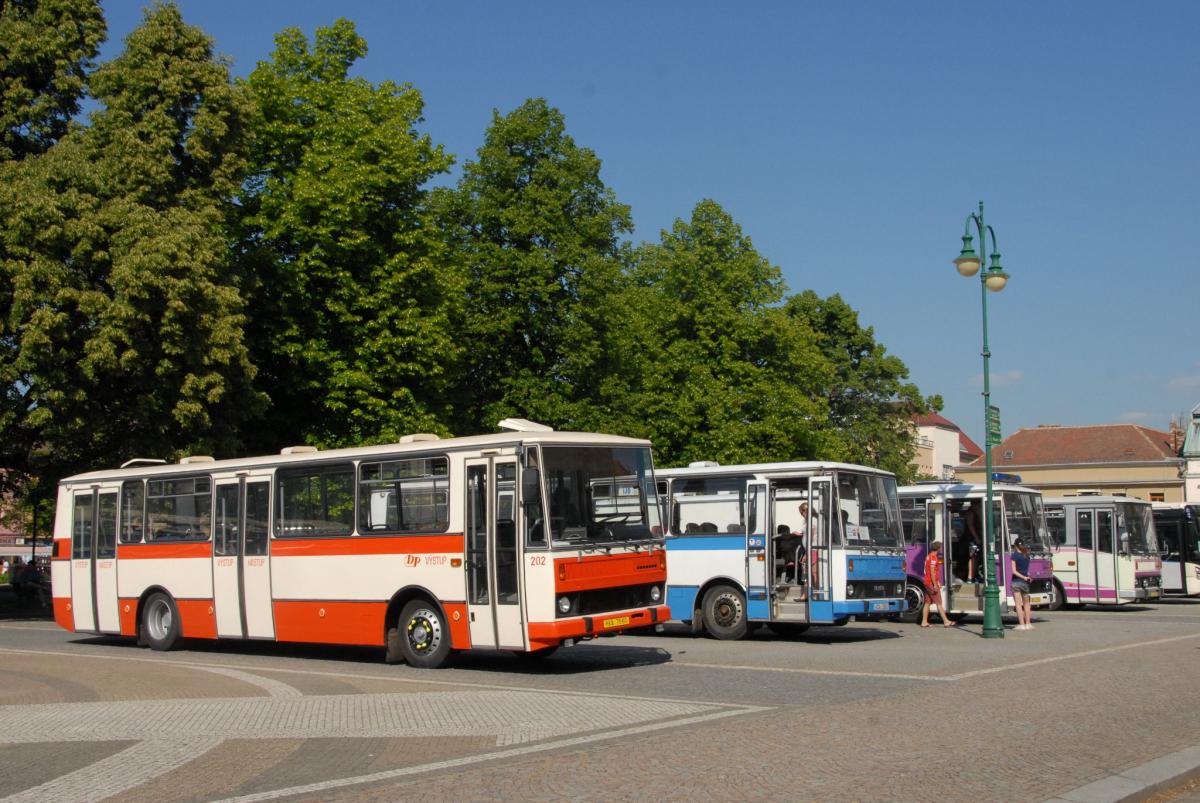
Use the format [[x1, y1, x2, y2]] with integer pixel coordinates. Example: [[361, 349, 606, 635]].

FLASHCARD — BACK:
[[898, 481, 1055, 622]]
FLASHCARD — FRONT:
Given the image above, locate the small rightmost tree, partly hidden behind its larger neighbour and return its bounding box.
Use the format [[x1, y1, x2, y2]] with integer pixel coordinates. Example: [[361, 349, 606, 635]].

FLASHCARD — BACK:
[[785, 290, 941, 480]]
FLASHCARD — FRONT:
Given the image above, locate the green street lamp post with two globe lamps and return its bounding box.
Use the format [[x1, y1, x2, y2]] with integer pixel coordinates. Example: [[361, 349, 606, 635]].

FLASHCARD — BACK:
[[954, 200, 1008, 639]]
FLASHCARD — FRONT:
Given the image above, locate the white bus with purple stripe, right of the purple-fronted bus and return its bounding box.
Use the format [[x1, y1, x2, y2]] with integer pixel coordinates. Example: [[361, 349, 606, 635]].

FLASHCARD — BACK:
[[1045, 496, 1163, 605]]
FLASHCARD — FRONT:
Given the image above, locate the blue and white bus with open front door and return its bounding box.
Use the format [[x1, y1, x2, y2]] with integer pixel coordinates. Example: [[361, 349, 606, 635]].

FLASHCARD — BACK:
[[655, 462, 905, 639]]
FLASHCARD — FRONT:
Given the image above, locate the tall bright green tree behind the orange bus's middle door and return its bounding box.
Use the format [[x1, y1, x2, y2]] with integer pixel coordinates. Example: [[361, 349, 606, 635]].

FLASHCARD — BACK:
[[240, 19, 462, 447]]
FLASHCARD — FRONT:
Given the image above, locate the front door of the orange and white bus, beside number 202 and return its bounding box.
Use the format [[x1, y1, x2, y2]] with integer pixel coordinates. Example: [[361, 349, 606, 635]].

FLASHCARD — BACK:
[[464, 457, 527, 649]]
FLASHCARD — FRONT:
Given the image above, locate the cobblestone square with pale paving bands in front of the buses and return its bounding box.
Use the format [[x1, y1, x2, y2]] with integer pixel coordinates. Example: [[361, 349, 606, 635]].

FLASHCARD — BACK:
[[0, 601, 1200, 802]]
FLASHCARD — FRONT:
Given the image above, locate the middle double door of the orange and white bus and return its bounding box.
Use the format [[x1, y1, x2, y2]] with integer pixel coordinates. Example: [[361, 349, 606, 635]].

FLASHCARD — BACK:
[[212, 474, 275, 639]]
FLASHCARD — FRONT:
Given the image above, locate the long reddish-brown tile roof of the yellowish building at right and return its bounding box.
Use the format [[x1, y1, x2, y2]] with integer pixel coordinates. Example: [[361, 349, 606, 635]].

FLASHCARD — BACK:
[[991, 424, 1178, 467]]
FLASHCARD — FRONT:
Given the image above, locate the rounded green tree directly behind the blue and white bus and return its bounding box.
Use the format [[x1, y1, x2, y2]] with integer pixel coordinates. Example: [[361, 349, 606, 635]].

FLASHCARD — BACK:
[[606, 200, 839, 465]]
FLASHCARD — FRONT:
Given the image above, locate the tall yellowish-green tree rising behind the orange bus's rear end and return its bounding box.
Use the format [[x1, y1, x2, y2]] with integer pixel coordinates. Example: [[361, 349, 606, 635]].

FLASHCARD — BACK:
[[0, 5, 260, 478]]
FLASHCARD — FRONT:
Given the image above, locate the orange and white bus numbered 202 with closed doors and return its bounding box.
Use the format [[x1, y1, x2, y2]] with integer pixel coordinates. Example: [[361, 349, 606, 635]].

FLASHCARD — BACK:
[[52, 419, 670, 667]]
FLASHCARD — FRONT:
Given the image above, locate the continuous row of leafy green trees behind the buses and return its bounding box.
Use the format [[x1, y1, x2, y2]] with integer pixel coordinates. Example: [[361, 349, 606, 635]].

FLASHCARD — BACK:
[[0, 0, 938, 501]]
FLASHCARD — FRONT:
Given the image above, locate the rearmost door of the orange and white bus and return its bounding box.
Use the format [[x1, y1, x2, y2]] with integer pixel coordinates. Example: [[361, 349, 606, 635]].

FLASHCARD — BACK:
[[71, 486, 121, 633]]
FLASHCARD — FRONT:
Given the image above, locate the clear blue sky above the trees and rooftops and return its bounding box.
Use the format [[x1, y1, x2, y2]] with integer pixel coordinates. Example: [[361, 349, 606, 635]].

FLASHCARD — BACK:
[[103, 0, 1200, 441]]
